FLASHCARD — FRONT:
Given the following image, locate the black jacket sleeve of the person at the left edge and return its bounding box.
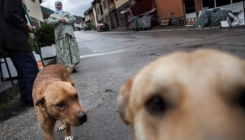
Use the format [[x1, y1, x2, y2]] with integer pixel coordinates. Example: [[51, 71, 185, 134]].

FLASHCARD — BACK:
[[3, 0, 29, 33]]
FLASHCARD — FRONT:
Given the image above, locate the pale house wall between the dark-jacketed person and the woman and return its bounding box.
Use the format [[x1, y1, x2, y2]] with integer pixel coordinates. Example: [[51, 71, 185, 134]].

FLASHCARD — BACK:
[[23, 0, 44, 28]]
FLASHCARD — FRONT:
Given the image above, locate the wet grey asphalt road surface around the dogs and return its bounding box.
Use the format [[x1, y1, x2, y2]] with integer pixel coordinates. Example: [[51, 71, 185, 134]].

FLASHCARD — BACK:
[[0, 28, 245, 140]]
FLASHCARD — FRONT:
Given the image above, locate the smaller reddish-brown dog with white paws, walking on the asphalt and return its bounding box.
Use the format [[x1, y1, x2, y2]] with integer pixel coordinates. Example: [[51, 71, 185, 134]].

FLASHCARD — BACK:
[[32, 65, 87, 140]]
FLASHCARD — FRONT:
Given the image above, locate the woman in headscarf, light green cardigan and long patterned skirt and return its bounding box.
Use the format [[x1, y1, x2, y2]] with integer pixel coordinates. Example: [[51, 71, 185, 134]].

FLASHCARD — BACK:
[[47, 1, 80, 73]]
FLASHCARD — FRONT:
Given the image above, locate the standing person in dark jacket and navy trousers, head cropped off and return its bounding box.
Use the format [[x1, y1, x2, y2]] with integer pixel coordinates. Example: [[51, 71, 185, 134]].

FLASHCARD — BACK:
[[0, 0, 39, 106]]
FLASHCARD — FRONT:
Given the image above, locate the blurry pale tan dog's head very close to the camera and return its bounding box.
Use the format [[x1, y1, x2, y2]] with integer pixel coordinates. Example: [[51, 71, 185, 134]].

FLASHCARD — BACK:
[[118, 49, 245, 140]]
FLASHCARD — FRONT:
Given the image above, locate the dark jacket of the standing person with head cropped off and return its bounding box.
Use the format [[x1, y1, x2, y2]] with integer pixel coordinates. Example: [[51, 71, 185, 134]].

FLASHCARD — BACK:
[[0, 0, 31, 51]]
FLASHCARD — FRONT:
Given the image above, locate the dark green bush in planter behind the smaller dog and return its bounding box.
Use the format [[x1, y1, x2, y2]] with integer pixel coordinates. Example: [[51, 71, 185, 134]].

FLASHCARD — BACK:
[[36, 22, 55, 47]]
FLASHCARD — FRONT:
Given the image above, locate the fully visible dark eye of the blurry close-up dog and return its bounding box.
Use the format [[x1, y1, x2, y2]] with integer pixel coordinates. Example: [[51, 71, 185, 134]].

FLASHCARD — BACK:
[[145, 96, 166, 115]]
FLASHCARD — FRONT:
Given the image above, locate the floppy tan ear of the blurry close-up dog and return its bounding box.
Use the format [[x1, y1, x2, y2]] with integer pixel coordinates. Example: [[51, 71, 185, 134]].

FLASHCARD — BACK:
[[117, 78, 133, 124]]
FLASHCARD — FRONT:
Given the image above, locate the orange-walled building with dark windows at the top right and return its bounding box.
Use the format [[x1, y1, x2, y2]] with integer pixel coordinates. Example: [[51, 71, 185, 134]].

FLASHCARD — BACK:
[[155, 0, 244, 24]]
